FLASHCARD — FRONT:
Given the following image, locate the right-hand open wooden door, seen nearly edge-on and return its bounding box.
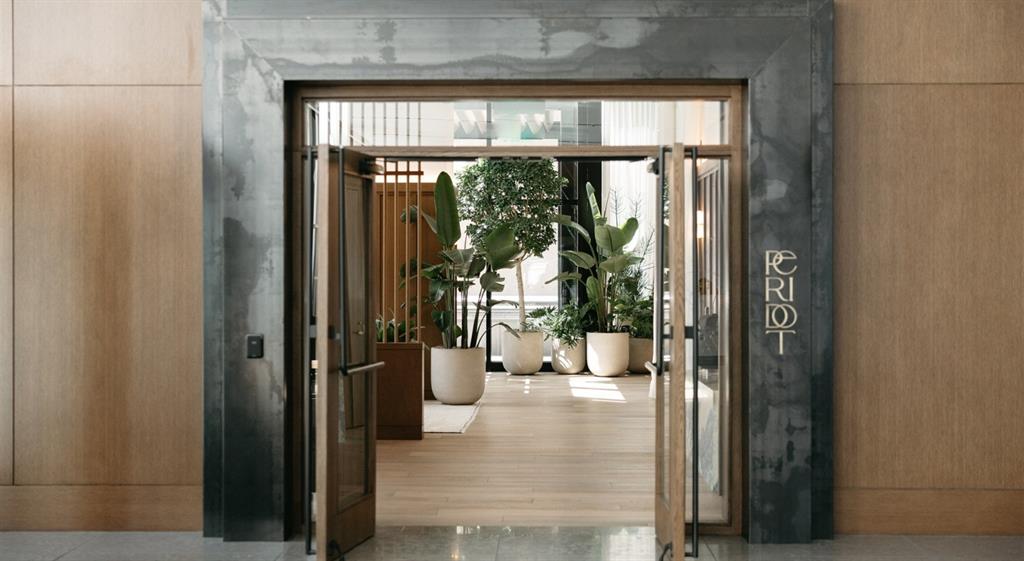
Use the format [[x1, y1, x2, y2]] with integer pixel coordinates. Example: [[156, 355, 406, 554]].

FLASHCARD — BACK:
[[651, 144, 696, 561]]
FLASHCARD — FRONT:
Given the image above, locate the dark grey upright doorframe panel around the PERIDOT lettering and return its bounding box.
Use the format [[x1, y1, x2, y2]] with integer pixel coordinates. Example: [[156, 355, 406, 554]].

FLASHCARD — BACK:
[[746, 23, 812, 543]]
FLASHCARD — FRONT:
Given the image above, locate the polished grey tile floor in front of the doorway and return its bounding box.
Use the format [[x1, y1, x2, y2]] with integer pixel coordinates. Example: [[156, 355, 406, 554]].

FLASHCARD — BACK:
[[0, 526, 1024, 561]]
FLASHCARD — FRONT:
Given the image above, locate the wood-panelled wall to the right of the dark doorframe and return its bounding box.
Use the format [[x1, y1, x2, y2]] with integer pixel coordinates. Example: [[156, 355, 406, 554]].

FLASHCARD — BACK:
[[835, 0, 1024, 533]]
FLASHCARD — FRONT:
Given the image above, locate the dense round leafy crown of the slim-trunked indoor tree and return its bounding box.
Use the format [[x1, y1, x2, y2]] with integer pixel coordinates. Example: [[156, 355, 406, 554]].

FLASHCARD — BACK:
[[459, 160, 567, 257]]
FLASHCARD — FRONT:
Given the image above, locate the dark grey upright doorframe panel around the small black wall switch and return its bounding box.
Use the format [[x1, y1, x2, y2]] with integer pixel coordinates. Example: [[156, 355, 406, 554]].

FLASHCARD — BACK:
[[221, 19, 288, 541]]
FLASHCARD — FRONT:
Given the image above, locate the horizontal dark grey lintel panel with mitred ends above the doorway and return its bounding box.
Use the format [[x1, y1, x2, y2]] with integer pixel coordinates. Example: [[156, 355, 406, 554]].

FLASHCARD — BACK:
[[231, 17, 801, 80]]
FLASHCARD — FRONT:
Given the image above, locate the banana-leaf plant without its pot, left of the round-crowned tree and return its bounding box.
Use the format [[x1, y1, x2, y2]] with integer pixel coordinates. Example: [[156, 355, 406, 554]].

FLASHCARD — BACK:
[[417, 172, 522, 349]]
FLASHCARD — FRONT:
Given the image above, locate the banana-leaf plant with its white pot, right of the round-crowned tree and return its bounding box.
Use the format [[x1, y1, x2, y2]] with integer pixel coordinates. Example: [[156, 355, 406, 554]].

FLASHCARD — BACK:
[[549, 183, 642, 376]]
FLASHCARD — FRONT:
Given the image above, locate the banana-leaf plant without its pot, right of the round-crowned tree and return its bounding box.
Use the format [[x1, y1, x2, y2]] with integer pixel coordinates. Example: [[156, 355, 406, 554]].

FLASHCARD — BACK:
[[548, 182, 643, 333]]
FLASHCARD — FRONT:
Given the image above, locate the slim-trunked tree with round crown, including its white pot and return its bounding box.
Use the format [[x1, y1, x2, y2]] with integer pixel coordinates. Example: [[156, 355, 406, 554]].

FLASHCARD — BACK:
[[459, 160, 566, 374]]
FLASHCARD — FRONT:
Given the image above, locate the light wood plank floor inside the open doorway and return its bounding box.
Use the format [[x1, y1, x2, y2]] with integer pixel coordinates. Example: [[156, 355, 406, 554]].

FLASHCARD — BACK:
[[377, 373, 654, 526]]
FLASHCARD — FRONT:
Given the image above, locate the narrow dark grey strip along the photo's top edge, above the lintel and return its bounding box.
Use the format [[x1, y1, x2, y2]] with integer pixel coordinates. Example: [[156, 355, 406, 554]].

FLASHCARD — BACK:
[[227, 0, 820, 19]]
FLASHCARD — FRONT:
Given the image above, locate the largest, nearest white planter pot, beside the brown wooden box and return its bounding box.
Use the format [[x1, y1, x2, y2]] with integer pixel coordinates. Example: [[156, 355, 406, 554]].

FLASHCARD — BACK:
[[430, 347, 486, 405]]
